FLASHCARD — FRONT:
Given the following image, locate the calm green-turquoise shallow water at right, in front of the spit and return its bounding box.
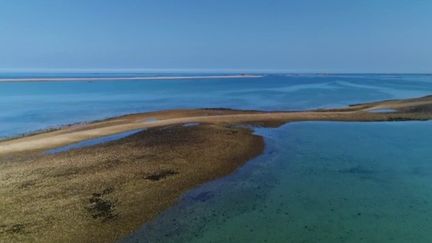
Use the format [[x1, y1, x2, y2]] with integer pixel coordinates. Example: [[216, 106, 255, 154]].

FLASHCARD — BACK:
[[125, 122, 432, 242]]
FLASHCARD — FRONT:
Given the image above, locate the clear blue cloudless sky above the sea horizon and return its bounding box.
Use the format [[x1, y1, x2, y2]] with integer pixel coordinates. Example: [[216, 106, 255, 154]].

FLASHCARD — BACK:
[[0, 0, 432, 72]]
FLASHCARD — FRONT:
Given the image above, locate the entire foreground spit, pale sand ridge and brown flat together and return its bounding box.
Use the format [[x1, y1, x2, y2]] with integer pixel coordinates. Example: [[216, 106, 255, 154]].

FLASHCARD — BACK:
[[0, 96, 432, 242]]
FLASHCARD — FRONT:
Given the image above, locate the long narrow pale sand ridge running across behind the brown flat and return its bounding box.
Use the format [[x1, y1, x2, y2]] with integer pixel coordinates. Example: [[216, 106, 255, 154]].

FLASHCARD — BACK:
[[0, 96, 432, 154]]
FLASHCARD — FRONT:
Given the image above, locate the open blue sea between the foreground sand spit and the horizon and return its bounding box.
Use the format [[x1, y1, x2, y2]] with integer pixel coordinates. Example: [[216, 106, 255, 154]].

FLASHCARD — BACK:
[[0, 74, 432, 138]]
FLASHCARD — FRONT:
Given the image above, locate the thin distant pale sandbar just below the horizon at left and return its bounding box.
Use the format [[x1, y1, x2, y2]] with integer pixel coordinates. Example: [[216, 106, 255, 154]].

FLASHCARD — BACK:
[[0, 74, 263, 83]]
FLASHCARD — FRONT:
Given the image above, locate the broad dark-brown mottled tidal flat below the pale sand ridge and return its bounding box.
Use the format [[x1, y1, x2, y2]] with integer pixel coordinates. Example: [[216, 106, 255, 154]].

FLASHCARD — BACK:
[[0, 125, 264, 242]]
